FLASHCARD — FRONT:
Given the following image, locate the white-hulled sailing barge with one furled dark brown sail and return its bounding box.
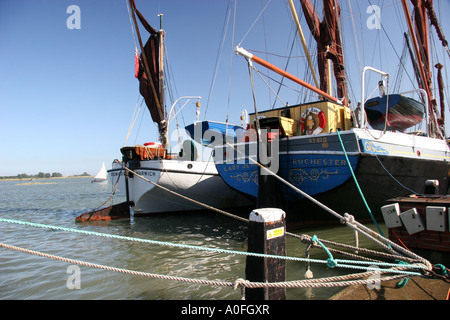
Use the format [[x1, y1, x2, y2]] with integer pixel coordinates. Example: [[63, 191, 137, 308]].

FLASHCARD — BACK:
[[108, 0, 251, 215]]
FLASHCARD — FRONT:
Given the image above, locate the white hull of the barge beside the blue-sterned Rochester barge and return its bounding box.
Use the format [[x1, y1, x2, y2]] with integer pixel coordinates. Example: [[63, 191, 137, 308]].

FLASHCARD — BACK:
[[108, 160, 252, 214]]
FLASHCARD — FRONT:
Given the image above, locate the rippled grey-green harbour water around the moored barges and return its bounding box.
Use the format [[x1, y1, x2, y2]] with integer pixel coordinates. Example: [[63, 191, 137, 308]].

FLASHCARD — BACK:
[[0, 178, 386, 300]]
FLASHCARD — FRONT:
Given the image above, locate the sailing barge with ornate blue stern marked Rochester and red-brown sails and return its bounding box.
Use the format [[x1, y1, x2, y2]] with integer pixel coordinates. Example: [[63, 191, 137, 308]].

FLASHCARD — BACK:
[[215, 0, 450, 222]]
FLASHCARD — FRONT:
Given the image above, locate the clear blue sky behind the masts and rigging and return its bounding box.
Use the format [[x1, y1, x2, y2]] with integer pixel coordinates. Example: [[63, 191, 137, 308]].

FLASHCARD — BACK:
[[0, 0, 450, 176]]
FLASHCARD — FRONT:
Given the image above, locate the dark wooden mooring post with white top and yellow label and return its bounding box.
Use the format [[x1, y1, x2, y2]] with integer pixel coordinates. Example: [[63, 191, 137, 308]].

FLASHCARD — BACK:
[[245, 208, 286, 300]]
